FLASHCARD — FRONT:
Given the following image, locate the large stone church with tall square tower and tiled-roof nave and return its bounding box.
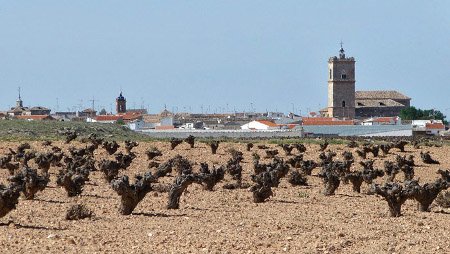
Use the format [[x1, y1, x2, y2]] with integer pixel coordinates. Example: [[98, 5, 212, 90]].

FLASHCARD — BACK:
[[320, 44, 411, 119]]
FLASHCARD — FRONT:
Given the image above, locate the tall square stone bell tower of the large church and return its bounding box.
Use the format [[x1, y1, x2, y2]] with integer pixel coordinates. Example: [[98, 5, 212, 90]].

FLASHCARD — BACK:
[[328, 43, 355, 119]]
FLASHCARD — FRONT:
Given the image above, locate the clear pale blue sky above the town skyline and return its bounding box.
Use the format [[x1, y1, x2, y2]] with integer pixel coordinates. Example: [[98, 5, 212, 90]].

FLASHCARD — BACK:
[[0, 0, 450, 114]]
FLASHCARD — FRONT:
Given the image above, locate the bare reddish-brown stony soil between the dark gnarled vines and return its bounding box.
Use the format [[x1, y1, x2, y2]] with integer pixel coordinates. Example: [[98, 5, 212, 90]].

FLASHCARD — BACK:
[[0, 142, 450, 253]]
